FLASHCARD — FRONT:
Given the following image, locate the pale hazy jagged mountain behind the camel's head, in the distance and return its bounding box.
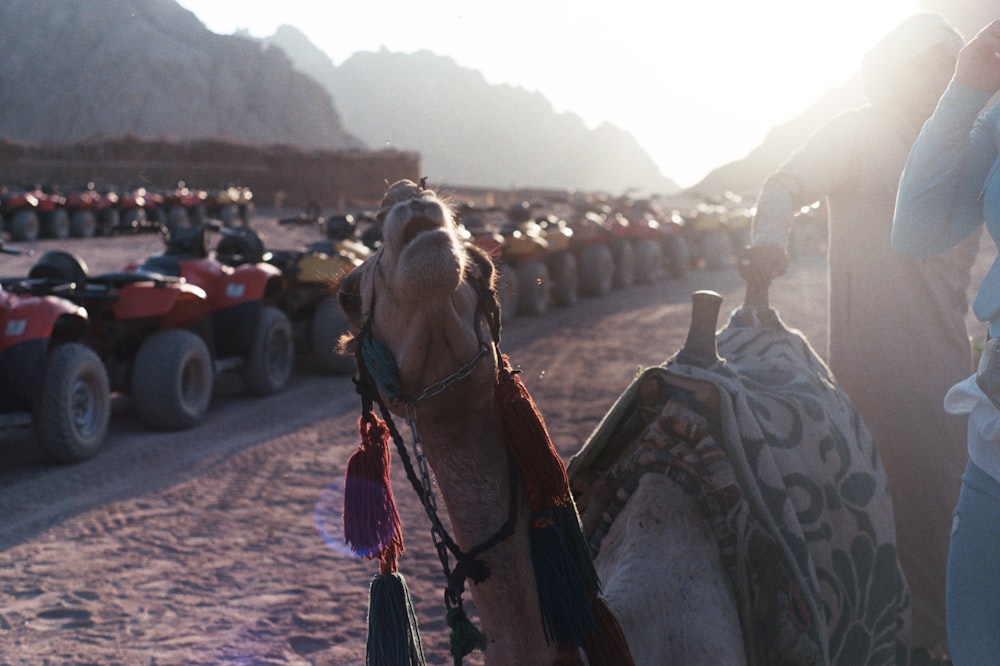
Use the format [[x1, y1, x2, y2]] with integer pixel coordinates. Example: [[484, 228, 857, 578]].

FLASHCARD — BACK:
[[268, 26, 678, 193]]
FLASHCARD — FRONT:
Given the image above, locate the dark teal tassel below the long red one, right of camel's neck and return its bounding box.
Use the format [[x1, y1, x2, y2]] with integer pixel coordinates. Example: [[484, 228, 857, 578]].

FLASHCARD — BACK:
[[529, 509, 596, 646]]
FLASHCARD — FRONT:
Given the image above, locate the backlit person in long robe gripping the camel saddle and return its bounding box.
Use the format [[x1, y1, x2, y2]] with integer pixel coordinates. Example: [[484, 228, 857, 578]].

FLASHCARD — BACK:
[[740, 12, 978, 655]]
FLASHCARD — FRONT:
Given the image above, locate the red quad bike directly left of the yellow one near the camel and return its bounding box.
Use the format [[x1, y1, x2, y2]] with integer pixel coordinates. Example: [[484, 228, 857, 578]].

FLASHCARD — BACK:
[[126, 222, 294, 395]]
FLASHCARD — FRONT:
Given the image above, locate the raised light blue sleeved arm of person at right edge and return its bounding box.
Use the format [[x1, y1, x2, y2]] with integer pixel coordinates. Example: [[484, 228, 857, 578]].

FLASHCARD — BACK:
[[892, 21, 1000, 257]]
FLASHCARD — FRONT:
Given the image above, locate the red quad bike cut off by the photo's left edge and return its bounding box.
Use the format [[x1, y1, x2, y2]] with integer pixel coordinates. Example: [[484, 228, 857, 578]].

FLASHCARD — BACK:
[[0, 240, 111, 462]]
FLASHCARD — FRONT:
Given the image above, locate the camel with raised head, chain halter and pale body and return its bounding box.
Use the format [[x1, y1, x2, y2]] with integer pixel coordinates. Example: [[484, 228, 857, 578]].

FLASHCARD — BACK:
[[338, 181, 912, 666]]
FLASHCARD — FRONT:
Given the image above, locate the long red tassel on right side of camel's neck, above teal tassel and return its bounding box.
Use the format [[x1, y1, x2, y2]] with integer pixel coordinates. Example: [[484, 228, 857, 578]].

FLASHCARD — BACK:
[[494, 354, 571, 511]]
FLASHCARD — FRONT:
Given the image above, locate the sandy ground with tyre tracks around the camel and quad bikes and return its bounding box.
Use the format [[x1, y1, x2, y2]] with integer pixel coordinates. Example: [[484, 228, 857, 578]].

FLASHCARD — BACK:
[[0, 214, 992, 666]]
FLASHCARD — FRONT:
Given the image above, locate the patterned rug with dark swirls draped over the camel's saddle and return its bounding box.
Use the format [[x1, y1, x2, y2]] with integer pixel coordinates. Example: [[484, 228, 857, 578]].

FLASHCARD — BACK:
[[569, 308, 909, 666]]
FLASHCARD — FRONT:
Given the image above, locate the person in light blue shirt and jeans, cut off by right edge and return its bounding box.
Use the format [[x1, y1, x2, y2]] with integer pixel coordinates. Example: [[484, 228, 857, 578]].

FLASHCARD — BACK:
[[892, 21, 1000, 666]]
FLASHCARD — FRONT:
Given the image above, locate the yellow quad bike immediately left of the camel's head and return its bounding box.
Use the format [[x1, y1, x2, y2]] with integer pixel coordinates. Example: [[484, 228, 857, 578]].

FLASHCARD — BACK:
[[215, 218, 371, 375]]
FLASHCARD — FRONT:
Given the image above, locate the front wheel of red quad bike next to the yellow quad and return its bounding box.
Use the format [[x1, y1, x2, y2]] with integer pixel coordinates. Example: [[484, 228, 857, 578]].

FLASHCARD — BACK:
[[243, 306, 295, 395]]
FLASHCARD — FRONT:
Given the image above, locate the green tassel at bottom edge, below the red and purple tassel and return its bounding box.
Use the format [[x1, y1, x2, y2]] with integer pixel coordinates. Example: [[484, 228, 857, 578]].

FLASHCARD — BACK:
[[365, 573, 426, 666]]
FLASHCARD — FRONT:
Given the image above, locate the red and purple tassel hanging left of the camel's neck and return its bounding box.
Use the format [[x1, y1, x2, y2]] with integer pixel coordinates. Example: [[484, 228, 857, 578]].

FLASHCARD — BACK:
[[344, 404, 403, 564]]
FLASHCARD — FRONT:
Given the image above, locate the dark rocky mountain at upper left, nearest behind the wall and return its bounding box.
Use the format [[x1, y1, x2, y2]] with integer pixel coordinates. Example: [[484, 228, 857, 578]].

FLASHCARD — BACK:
[[0, 0, 365, 149]]
